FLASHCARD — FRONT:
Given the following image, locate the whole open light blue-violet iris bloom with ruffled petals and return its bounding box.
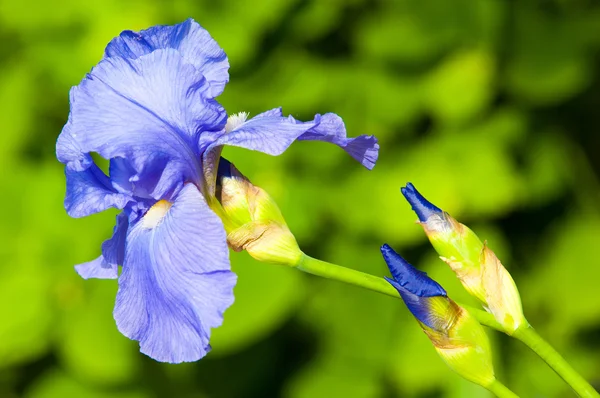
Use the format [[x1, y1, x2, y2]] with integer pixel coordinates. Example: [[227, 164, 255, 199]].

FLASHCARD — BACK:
[[56, 19, 379, 363]]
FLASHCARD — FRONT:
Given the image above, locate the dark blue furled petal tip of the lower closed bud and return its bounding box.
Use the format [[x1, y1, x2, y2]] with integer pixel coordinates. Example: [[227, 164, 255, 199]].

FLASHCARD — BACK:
[[381, 244, 446, 297]]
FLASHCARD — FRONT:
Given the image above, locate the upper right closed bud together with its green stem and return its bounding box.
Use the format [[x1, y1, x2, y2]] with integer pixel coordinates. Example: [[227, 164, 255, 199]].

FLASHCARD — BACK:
[[402, 183, 600, 397]]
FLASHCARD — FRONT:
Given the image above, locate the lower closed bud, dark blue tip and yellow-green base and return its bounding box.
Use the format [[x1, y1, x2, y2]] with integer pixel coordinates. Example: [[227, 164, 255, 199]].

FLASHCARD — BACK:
[[381, 245, 496, 388]]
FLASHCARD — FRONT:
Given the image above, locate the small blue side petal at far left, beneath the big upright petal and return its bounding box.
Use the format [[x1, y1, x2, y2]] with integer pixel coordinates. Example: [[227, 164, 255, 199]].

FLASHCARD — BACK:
[[65, 163, 131, 217]]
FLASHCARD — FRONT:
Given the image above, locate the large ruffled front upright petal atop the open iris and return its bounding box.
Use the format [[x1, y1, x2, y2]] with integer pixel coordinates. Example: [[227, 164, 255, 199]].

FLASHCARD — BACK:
[[57, 49, 226, 199]]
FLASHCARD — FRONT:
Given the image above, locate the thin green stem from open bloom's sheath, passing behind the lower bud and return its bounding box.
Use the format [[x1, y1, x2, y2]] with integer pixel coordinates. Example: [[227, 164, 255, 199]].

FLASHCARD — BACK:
[[296, 254, 504, 332]]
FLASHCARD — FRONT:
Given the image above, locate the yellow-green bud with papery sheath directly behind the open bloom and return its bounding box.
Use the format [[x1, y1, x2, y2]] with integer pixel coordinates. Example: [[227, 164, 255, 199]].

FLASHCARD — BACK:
[[212, 158, 302, 266]]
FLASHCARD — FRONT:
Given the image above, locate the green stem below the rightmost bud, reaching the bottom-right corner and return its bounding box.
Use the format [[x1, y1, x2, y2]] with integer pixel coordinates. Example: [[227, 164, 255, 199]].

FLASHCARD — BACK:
[[513, 325, 600, 398]]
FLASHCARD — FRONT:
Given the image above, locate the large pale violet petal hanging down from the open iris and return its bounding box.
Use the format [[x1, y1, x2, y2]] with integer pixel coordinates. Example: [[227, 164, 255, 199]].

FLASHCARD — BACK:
[[114, 184, 236, 363]]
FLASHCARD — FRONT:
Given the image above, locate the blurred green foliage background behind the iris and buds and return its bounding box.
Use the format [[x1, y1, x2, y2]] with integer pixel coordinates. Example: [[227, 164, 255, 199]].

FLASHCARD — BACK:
[[0, 0, 600, 398]]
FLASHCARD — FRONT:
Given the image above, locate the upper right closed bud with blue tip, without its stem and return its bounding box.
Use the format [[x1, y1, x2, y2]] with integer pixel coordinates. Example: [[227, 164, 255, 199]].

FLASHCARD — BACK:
[[402, 183, 526, 334]]
